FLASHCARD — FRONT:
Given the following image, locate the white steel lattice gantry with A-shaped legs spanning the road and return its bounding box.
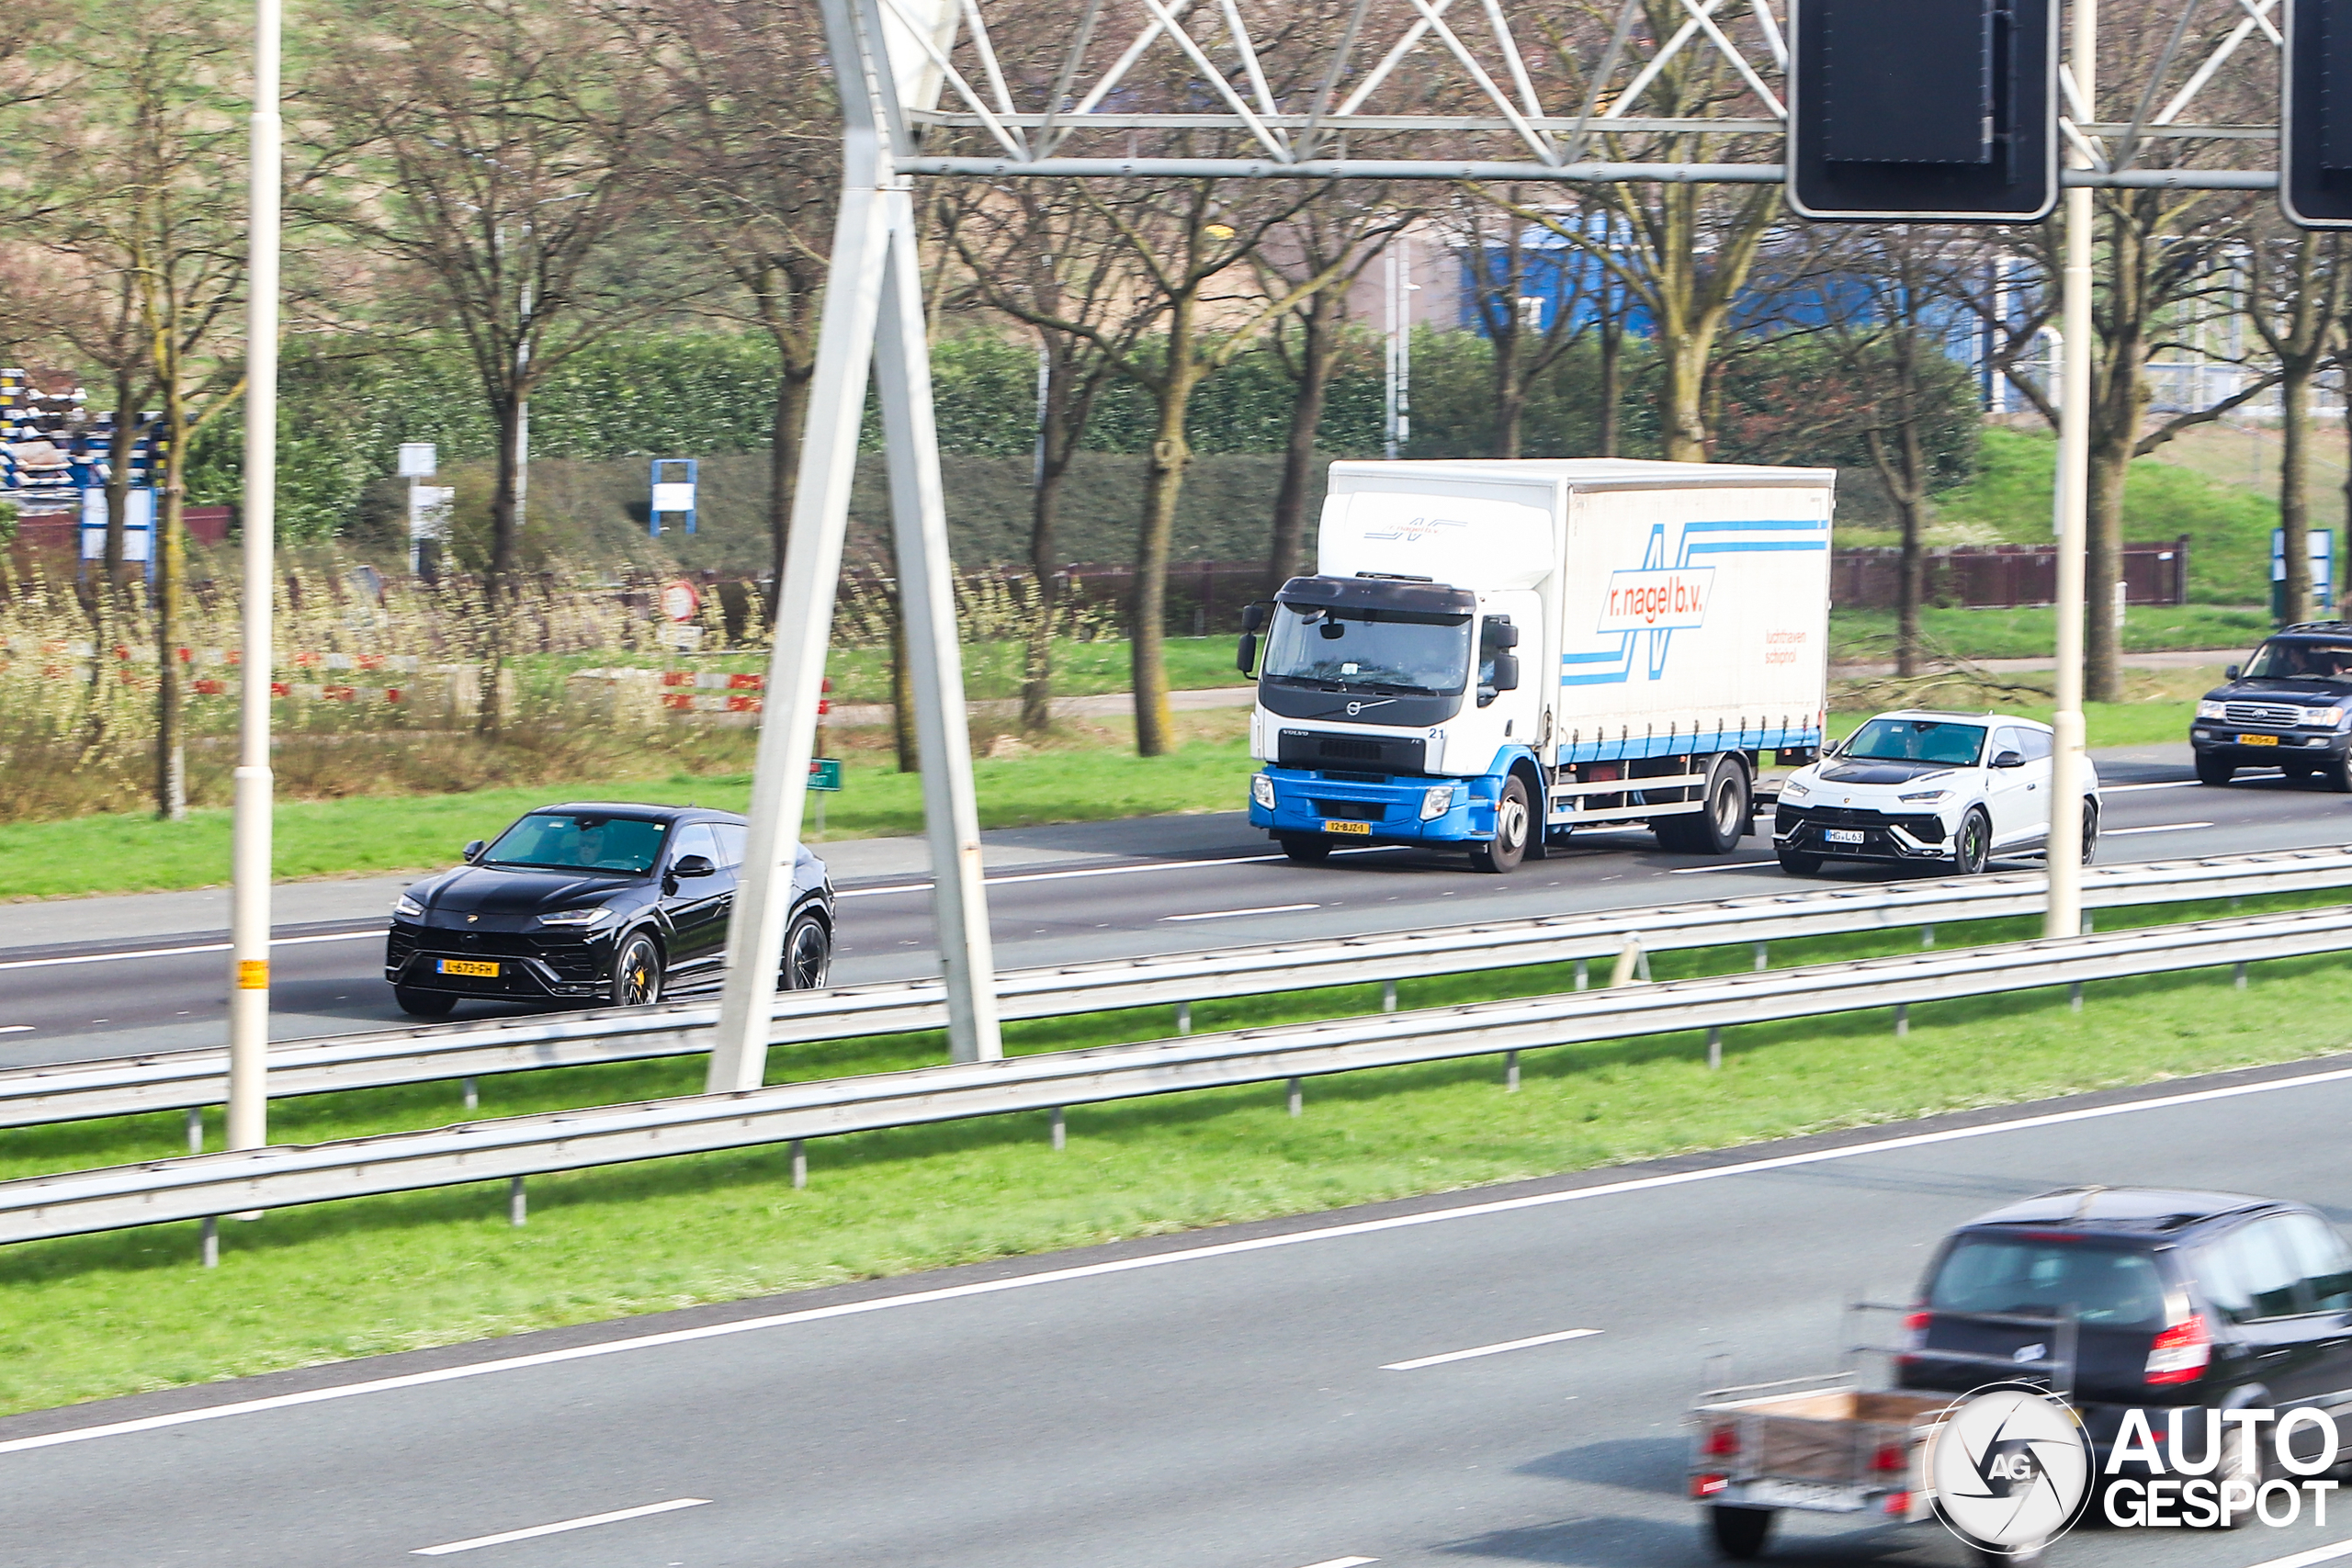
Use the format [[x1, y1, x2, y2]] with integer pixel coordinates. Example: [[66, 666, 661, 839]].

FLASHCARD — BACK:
[[710, 0, 2281, 1090]]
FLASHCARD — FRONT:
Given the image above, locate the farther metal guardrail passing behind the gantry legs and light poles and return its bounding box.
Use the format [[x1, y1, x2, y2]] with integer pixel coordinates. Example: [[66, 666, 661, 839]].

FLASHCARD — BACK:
[[14, 846, 2352, 1128]]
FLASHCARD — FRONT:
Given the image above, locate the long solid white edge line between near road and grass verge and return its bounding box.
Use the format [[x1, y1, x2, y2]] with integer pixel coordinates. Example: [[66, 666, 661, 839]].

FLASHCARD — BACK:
[[14, 1067, 2352, 1453]]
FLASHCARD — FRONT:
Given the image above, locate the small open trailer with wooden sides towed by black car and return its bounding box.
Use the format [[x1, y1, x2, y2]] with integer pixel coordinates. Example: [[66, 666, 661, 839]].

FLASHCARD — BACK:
[[1684, 1373, 1952, 1561]]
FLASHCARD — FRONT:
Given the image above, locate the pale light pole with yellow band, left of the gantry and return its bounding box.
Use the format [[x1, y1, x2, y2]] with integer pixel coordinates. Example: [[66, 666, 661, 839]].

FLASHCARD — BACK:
[[228, 0, 280, 1149]]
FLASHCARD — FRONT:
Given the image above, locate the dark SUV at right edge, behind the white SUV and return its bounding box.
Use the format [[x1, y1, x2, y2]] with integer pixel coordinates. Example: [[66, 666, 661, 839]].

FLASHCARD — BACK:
[[2189, 621, 2352, 792]]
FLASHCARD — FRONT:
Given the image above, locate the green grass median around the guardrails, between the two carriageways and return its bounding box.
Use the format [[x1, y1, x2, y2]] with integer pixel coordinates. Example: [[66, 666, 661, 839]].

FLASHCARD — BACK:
[[0, 893, 2352, 1413]]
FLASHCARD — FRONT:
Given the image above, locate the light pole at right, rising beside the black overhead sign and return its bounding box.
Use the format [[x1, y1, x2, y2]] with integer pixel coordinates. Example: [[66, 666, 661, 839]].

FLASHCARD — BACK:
[[2041, 0, 2098, 936]]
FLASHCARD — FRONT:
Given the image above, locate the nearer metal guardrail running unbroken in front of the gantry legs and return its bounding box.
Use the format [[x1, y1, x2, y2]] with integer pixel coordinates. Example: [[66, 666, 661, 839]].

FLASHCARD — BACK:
[[0, 908, 2352, 1244]]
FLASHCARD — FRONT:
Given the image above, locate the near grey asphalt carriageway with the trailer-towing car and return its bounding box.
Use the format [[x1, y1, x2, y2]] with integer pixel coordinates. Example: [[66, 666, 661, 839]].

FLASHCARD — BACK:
[[14, 1058, 2352, 1568]]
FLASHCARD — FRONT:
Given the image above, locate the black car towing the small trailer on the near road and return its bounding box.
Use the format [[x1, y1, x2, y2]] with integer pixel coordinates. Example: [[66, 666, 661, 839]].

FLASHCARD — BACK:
[[1895, 1187, 2352, 1467]]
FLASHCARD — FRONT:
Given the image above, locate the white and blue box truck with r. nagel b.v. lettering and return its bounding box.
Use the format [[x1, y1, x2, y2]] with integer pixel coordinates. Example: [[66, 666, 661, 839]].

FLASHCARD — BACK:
[[1239, 458, 1837, 872]]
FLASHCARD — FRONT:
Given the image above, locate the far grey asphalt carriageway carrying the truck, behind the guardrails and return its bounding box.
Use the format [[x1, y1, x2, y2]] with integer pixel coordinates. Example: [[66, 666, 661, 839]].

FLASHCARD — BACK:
[[0, 745, 2352, 1065]]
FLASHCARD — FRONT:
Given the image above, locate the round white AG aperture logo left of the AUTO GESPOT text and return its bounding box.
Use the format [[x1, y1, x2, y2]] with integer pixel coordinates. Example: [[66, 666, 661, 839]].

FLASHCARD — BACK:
[[1927, 1382, 2091, 1561]]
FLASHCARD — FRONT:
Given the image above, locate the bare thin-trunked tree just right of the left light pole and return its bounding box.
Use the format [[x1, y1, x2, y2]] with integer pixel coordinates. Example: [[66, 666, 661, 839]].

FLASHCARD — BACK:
[[311, 0, 680, 728]]
